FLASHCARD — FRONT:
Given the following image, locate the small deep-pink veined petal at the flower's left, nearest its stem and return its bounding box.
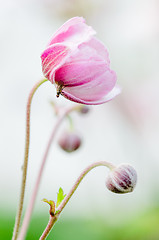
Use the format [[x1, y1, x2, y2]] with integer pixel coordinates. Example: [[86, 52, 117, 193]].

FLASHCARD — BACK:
[[41, 44, 70, 82]]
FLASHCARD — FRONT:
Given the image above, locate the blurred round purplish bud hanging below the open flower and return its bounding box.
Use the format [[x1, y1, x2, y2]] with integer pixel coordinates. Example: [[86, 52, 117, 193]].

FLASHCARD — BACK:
[[58, 132, 81, 153]]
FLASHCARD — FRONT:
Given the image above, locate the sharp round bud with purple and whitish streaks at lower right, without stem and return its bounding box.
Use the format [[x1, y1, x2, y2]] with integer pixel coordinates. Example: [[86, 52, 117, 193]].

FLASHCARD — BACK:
[[106, 164, 137, 193]]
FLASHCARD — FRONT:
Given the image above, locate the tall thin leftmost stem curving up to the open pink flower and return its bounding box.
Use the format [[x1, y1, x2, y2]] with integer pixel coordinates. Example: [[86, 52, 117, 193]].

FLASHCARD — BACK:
[[12, 79, 48, 240]]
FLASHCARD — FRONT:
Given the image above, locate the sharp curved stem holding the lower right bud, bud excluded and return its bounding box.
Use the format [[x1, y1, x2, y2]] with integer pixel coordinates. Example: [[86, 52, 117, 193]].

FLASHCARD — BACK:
[[40, 161, 115, 240]]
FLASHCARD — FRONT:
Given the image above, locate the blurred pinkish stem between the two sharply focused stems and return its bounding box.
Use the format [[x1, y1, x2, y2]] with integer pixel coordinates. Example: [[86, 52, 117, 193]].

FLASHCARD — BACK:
[[18, 105, 82, 240]]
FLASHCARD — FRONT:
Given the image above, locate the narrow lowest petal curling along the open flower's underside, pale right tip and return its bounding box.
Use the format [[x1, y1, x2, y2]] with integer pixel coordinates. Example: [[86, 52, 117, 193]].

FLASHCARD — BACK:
[[62, 85, 121, 105]]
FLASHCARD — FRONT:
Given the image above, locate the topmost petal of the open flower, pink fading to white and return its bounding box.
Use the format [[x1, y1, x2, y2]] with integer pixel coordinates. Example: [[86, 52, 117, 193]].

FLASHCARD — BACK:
[[48, 17, 95, 47]]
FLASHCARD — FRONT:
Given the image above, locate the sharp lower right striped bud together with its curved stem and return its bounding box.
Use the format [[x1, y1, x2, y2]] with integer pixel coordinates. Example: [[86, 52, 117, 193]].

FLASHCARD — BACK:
[[40, 161, 137, 240]]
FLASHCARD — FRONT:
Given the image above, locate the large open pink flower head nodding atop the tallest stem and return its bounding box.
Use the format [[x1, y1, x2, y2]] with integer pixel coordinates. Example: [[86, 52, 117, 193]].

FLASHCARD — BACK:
[[41, 17, 120, 105]]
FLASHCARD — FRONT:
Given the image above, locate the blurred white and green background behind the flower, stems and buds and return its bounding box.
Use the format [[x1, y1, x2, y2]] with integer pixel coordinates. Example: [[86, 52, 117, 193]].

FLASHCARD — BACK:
[[0, 0, 159, 240]]
